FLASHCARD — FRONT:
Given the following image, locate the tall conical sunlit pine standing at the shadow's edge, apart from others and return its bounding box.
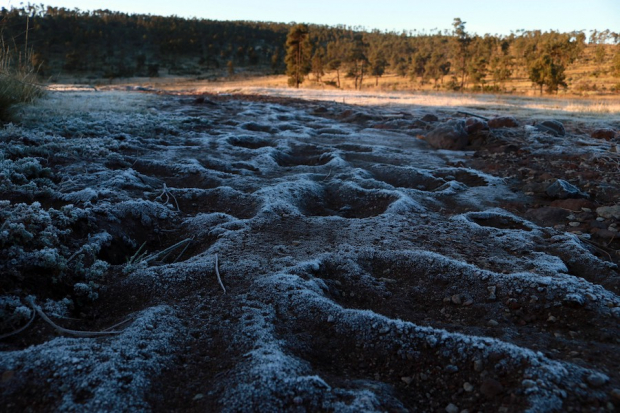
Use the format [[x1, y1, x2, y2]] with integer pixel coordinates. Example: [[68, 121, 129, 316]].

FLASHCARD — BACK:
[[285, 24, 312, 88]]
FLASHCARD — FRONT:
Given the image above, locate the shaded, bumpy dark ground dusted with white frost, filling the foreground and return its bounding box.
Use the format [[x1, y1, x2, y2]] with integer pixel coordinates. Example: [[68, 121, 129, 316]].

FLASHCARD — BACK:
[[0, 88, 620, 412]]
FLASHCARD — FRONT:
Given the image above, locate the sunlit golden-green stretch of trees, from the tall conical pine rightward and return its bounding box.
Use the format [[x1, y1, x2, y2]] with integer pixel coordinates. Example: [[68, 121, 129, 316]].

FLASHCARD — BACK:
[[286, 18, 620, 94]]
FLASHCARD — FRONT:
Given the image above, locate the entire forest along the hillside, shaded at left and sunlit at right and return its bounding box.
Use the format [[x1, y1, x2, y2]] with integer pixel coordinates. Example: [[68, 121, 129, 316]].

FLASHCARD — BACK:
[[0, 5, 620, 93]]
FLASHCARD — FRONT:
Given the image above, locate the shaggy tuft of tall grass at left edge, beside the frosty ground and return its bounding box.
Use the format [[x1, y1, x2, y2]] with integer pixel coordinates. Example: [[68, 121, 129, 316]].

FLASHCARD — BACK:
[[0, 40, 44, 121]]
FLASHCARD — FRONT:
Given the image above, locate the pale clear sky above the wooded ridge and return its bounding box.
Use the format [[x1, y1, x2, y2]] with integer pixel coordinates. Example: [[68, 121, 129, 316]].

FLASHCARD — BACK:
[[0, 0, 620, 34]]
